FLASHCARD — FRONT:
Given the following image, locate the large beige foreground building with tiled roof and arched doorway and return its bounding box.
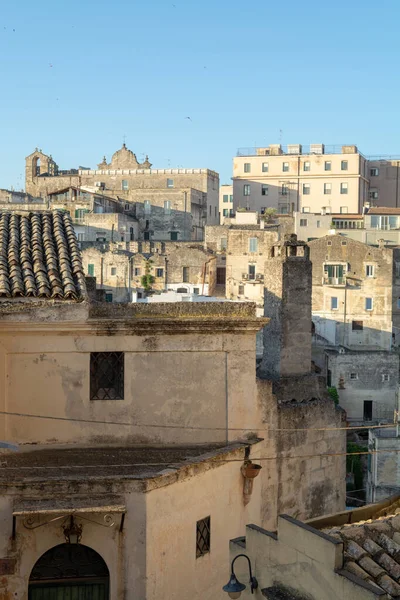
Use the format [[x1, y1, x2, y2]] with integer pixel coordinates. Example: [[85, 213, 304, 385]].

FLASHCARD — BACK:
[[0, 212, 345, 600]]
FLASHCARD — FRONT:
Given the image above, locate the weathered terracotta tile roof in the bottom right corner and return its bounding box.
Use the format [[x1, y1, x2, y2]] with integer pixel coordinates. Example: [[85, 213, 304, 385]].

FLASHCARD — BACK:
[[322, 501, 400, 599]]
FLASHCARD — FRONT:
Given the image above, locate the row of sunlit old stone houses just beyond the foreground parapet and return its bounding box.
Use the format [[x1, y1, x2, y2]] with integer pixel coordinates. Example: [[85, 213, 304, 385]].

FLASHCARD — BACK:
[[82, 242, 217, 302]]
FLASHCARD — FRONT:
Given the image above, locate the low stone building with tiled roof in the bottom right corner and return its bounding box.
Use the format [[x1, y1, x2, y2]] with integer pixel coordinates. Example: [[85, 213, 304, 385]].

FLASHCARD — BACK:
[[227, 496, 400, 600]]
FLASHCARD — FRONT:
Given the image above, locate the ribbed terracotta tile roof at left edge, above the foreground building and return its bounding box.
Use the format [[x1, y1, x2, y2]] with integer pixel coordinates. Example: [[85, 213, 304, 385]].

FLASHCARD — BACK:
[[0, 211, 86, 300]]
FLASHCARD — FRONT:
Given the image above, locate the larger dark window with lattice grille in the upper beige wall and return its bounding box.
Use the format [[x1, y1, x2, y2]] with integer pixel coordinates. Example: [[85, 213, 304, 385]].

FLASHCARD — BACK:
[[90, 352, 124, 400]]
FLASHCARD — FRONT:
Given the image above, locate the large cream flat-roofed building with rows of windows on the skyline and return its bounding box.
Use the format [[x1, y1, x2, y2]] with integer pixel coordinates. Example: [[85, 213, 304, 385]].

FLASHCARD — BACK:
[[233, 144, 400, 215]]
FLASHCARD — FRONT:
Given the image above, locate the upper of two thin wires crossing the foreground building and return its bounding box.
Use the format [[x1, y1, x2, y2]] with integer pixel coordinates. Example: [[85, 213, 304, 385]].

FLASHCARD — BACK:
[[0, 410, 397, 433]]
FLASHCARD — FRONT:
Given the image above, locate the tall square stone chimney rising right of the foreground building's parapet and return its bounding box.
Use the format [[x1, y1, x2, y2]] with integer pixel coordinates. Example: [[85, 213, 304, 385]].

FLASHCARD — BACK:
[[258, 234, 312, 380]]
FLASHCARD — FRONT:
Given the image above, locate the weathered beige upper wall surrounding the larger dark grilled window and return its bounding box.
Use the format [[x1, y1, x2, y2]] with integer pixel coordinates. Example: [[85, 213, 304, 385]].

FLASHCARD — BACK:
[[0, 303, 264, 444]]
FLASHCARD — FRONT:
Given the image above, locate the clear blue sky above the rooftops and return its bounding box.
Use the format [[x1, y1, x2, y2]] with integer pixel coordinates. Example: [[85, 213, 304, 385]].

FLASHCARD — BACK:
[[0, 0, 400, 188]]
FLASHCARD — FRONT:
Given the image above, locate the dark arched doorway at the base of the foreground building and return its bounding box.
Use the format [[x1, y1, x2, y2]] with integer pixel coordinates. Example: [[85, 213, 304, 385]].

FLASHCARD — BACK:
[[29, 544, 109, 600]]
